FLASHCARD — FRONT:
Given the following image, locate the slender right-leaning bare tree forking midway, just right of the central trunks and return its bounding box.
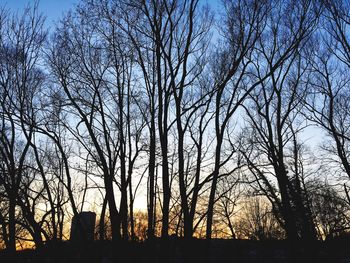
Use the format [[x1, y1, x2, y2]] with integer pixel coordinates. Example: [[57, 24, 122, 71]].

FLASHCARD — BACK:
[[206, 1, 268, 238]]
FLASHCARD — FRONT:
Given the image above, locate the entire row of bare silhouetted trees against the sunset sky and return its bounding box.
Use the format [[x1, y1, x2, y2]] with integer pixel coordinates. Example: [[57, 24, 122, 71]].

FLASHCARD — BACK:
[[0, 0, 350, 253]]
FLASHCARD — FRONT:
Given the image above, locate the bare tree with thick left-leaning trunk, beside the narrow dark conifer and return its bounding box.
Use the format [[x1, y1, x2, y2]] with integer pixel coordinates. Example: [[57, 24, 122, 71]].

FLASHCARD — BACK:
[[238, 1, 318, 240]]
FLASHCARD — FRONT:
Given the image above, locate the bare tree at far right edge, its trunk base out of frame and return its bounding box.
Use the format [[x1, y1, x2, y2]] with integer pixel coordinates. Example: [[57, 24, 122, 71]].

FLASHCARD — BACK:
[[305, 1, 350, 204]]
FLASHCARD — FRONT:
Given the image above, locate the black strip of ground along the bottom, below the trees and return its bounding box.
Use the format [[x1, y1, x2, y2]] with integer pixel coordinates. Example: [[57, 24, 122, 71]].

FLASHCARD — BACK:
[[0, 238, 350, 263]]
